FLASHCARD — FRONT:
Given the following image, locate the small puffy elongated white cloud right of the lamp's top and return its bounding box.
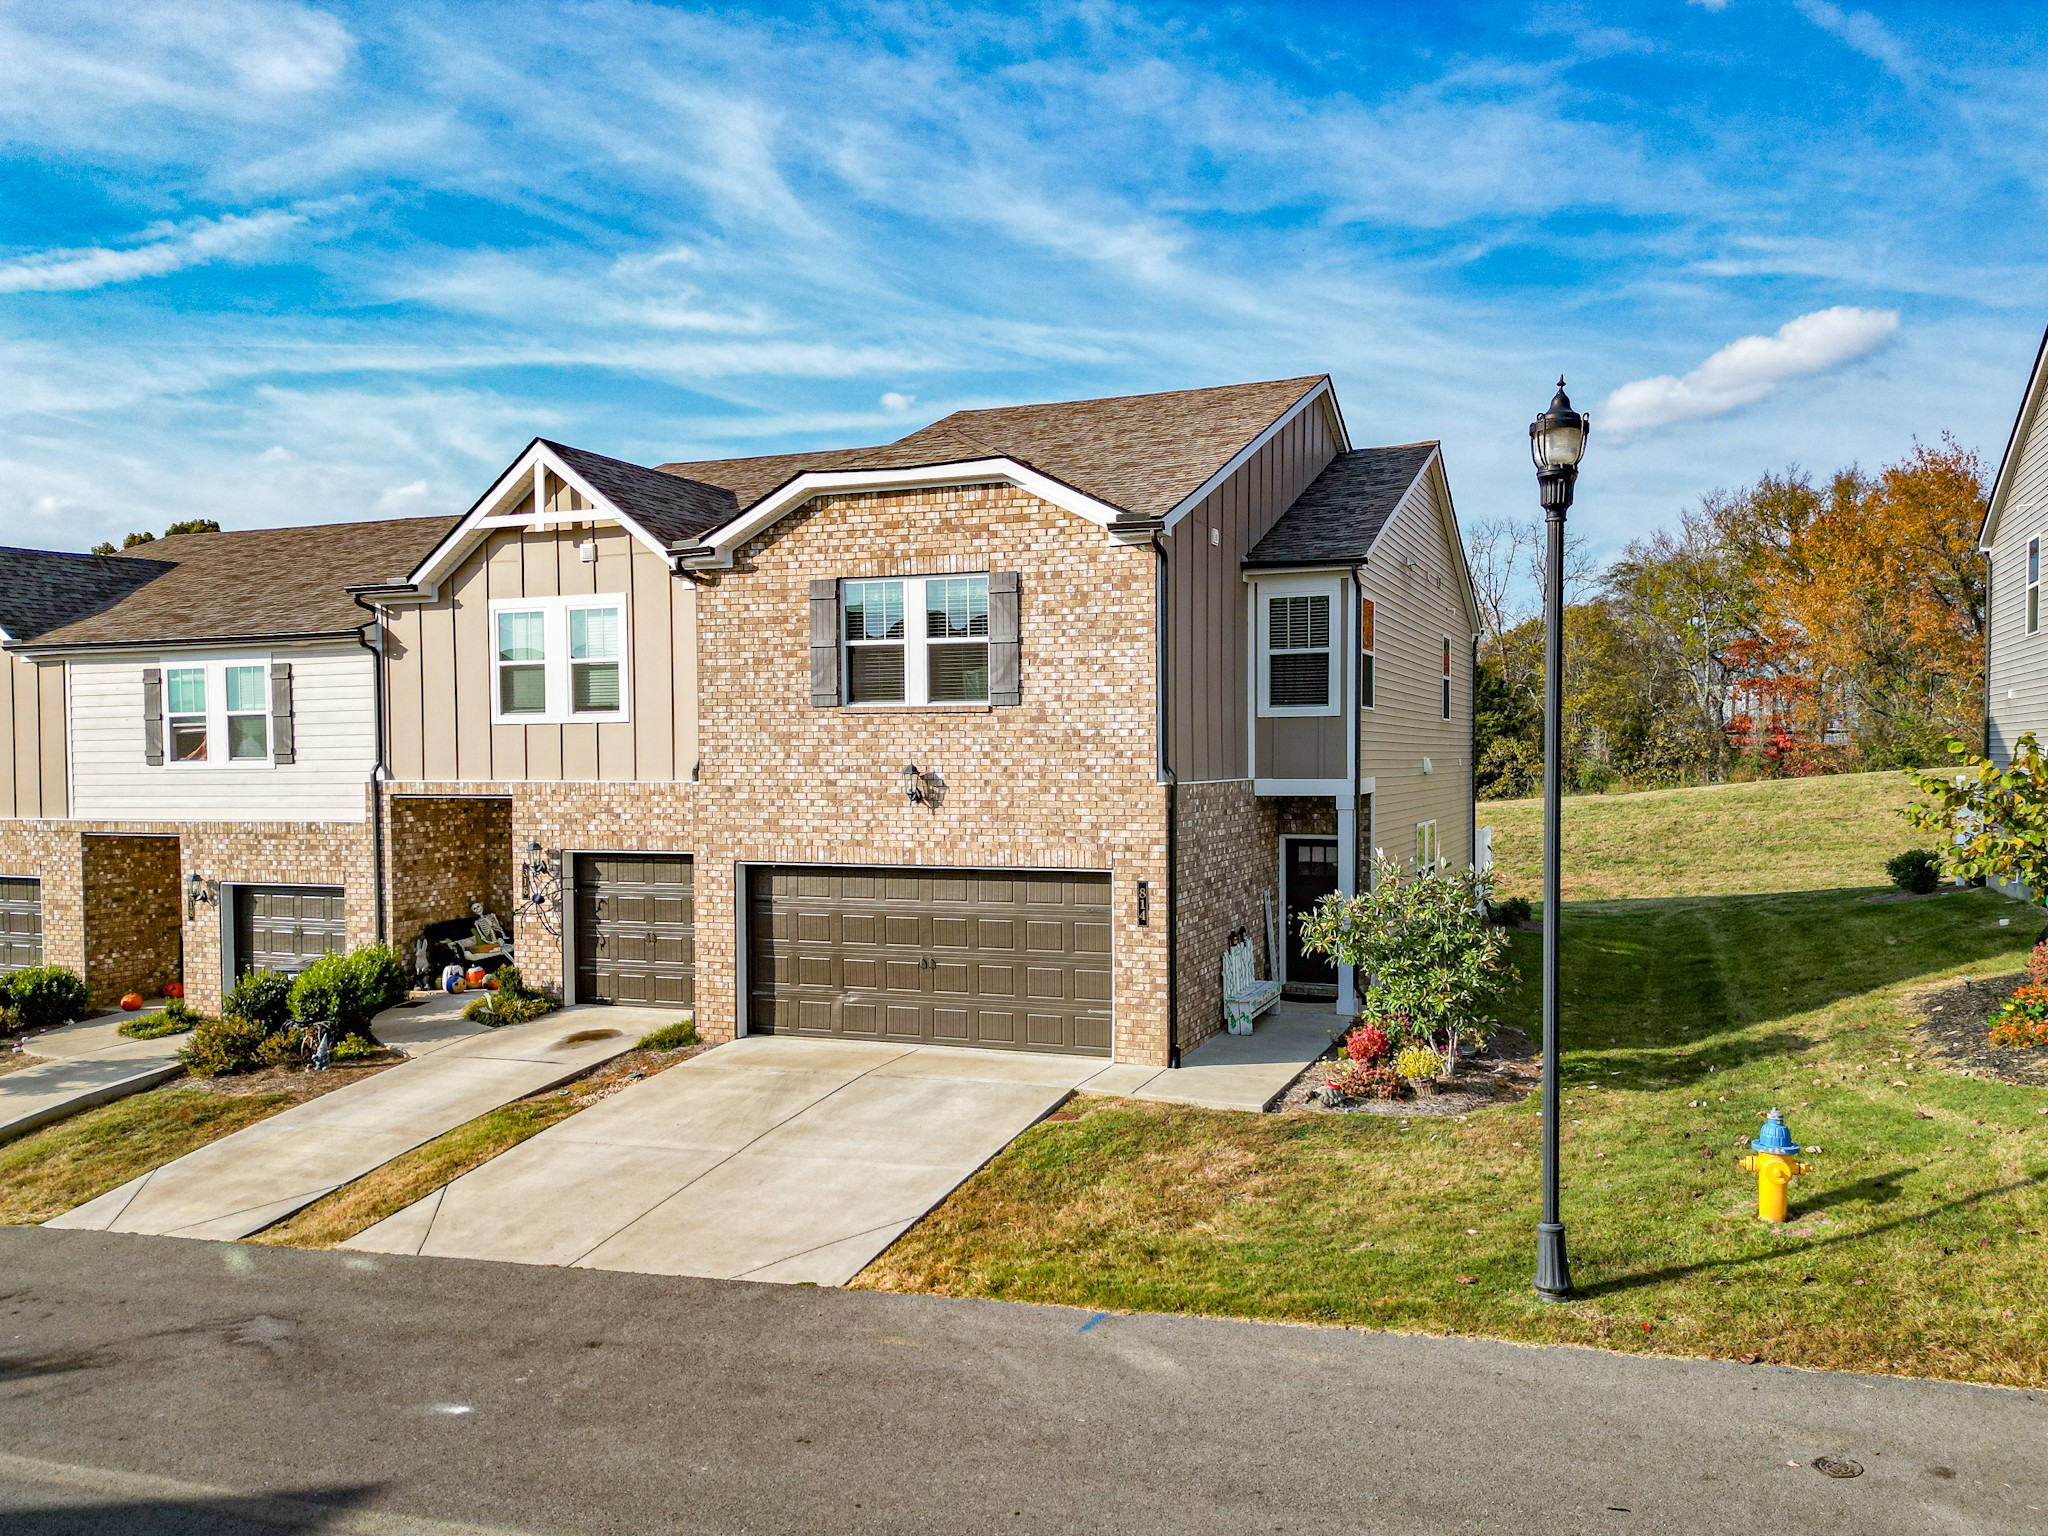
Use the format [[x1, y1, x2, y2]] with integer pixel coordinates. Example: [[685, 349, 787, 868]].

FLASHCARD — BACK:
[[1599, 305, 1898, 434]]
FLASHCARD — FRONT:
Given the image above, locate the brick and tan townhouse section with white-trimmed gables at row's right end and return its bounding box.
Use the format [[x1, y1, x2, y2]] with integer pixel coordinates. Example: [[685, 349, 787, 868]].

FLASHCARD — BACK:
[[356, 377, 1477, 1065]]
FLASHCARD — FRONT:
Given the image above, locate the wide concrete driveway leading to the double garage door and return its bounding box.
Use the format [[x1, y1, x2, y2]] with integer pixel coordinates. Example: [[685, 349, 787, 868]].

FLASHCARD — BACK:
[[346, 1036, 1124, 1286]]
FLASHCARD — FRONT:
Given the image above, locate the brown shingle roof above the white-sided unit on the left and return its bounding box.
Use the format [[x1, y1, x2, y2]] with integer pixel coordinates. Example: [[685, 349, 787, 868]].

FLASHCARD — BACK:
[[19, 518, 457, 649]]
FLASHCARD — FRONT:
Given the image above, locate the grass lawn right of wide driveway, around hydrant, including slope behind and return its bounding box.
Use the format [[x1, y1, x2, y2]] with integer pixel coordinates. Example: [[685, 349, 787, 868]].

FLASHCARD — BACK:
[[858, 774, 2048, 1386]]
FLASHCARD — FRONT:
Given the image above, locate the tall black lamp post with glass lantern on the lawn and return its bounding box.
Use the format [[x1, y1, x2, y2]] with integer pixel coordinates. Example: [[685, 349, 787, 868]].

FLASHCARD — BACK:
[[1530, 377, 1593, 1300]]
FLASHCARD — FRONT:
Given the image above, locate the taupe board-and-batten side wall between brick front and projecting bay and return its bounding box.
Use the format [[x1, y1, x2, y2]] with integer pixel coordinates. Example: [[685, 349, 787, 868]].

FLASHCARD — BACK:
[[1163, 401, 1343, 784]]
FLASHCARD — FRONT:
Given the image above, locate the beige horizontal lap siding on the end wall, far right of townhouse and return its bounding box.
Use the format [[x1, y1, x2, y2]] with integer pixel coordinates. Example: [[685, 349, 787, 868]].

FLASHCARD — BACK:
[[1360, 469, 1473, 868]]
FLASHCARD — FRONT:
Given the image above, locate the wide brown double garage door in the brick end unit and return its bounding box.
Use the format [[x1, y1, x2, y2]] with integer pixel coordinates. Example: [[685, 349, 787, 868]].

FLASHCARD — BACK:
[[748, 866, 1110, 1057]]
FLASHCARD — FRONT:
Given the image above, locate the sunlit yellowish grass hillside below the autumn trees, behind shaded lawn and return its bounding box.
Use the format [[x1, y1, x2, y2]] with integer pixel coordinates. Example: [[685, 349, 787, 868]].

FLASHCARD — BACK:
[[1479, 772, 1933, 901]]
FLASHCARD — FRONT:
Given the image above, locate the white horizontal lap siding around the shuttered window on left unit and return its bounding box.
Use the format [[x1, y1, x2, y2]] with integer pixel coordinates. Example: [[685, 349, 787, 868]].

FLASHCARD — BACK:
[[68, 643, 377, 821]]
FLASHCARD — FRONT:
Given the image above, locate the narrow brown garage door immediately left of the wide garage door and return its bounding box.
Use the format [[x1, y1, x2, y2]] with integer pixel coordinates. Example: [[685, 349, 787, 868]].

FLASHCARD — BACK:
[[575, 854, 696, 1008]]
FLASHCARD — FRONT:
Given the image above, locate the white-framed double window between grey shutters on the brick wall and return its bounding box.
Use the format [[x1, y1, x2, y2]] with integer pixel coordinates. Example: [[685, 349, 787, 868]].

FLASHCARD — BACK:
[[840, 575, 989, 705]]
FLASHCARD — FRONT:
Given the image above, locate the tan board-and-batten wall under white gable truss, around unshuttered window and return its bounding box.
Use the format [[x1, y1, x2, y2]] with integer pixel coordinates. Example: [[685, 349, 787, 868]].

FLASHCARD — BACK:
[[385, 526, 696, 782]]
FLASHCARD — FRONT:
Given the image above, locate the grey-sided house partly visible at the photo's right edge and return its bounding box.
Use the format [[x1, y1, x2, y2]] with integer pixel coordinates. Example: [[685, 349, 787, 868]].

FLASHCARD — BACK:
[[1976, 334, 2048, 766]]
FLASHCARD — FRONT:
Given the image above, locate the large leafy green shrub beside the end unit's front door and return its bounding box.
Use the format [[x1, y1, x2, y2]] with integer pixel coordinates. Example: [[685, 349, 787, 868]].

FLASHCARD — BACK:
[[1300, 856, 1507, 1061]]
